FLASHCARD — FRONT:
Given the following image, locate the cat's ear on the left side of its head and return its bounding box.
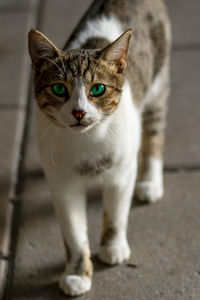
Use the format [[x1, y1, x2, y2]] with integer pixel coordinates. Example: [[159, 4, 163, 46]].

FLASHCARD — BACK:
[[28, 29, 59, 69]]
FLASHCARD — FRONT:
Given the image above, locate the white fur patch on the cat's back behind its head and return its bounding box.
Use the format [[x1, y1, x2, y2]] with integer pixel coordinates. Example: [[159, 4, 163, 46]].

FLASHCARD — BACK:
[[70, 15, 123, 49]]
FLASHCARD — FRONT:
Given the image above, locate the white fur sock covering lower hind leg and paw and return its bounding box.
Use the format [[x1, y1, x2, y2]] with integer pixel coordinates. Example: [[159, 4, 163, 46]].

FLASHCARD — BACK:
[[136, 156, 164, 202]]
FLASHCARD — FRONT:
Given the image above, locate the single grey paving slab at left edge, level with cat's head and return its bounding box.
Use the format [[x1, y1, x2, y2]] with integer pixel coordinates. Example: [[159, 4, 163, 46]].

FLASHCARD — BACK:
[[0, 11, 37, 109]]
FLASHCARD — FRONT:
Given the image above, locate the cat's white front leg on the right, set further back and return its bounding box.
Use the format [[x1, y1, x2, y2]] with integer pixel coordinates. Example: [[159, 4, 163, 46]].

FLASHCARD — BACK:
[[99, 162, 136, 264]]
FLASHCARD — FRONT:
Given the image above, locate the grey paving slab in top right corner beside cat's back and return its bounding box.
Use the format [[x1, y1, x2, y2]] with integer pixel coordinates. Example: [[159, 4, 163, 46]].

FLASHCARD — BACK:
[[165, 0, 200, 45]]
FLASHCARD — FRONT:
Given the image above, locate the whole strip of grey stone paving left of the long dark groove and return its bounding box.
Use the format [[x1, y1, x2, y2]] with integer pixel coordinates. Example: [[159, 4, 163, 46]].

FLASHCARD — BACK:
[[0, 0, 38, 298]]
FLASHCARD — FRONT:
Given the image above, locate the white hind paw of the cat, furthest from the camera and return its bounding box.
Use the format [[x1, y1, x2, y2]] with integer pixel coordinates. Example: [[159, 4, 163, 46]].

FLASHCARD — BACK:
[[135, 181, 163, 203]]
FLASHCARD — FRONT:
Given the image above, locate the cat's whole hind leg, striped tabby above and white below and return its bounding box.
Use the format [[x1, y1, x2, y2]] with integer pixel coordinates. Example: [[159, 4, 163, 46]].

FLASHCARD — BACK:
[[135, 74, 169, 202]]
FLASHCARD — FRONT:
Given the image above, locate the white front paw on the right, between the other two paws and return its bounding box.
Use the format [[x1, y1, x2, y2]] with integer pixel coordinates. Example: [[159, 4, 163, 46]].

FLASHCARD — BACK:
[[99, 242, 131, 265]]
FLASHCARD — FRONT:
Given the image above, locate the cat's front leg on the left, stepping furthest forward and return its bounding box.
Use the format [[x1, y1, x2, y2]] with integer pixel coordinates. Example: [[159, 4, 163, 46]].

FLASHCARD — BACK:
[[50, 180, 93, 296]]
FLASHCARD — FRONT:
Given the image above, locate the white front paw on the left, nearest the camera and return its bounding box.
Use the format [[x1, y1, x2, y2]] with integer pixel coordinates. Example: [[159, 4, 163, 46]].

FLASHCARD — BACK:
[[60, 274, 92, 296]]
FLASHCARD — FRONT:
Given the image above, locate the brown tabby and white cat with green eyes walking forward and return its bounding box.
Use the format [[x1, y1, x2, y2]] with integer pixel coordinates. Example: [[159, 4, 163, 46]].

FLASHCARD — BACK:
[[29, 0, 171, 296]]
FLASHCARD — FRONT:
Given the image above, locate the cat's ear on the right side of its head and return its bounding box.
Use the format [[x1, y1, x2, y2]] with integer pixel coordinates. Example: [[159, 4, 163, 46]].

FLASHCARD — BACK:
[[100, 29, 132, 73]]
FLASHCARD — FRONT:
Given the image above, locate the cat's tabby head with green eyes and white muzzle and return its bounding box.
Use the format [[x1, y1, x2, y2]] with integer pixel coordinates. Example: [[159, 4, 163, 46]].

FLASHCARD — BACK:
[[29, 30, 132, 132]]
